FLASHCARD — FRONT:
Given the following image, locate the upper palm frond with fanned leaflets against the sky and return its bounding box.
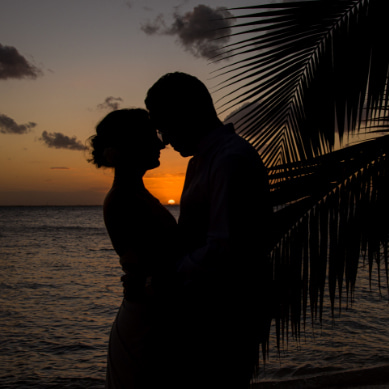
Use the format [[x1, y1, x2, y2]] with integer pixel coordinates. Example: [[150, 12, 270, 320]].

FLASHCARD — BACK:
[[218, 0, 389, 166]]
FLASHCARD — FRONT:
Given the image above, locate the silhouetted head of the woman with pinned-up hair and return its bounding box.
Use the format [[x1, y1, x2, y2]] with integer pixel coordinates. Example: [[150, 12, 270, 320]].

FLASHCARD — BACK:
[[89, 108, 165, 171]]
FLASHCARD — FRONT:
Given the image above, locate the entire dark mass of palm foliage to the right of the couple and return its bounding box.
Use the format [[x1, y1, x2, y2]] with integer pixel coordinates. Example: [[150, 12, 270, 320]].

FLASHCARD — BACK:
[[215, 0, 389, 356]]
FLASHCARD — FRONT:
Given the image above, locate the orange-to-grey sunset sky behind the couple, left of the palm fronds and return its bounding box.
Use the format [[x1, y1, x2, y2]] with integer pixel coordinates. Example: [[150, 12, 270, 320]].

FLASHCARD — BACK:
[[0, 0, 272, 205]]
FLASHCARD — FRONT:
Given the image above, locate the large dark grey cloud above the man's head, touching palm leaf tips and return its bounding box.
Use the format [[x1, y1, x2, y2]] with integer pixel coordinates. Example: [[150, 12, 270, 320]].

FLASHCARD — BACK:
[[141, 4, 234, 59]]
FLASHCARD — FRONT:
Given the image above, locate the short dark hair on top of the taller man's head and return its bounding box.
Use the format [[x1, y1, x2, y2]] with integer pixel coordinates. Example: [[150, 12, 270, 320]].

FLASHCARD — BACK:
[[145, 72, 217, 120]]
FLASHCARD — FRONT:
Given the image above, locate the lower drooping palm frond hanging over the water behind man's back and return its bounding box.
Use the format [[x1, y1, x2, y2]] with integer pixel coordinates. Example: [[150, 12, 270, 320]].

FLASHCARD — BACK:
[[269, 136, 389, 337]]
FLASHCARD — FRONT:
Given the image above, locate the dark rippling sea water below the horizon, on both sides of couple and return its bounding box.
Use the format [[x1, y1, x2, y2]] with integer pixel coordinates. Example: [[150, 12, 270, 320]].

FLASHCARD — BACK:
[[0, 206, 389, 389]]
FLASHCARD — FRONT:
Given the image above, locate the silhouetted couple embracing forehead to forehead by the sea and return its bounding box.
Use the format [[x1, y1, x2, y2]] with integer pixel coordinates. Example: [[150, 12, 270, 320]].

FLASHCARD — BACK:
[[91, 72, 272, 389]]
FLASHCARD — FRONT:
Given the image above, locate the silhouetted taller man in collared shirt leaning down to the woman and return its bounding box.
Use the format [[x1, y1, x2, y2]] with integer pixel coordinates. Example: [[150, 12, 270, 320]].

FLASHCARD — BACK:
[[145, 72, 272, 389]]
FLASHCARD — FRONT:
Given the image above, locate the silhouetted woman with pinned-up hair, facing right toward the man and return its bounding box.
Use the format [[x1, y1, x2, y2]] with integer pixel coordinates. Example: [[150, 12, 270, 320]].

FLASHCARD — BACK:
[[90, 108, 178, 389]]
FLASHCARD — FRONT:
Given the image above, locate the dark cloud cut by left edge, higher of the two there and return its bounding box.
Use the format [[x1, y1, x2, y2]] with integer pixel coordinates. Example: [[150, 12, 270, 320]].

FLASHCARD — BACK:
[[0, 43, 42, 80]]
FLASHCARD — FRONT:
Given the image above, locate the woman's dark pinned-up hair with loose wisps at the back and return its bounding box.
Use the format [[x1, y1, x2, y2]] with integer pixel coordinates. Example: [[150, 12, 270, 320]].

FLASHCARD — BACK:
[[89, 108, 150, 167]]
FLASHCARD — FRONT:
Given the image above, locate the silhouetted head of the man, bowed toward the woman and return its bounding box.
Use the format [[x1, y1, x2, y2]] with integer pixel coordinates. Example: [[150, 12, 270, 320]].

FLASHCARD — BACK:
[[145, 72, 221, 157]]
